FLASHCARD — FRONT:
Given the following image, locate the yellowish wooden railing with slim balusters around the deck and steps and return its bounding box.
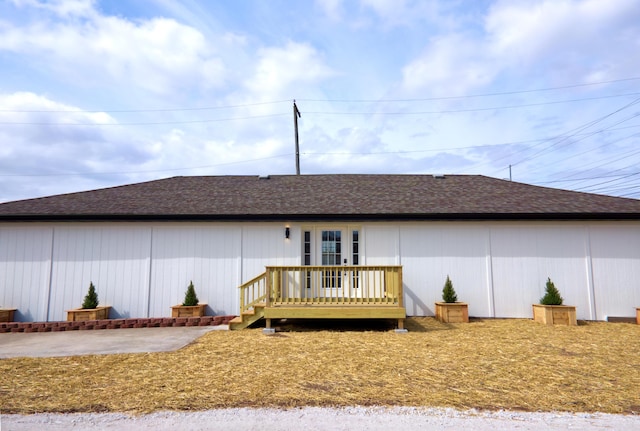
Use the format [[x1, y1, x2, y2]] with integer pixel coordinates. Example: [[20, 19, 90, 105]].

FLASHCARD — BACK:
[[240, 265, 403, 312]]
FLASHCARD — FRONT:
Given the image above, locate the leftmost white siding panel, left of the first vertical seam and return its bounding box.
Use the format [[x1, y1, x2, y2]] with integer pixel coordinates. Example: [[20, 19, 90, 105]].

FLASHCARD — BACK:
[[0, 226, 53, 321]]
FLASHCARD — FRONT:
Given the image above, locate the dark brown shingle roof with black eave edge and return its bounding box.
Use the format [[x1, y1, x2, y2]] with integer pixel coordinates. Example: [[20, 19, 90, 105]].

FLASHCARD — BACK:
[[0, 175, 640, 220]]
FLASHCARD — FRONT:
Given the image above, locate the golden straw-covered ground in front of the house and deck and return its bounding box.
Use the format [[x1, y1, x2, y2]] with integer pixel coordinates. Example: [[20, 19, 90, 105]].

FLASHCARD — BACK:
[[0, 318, 640, 414]]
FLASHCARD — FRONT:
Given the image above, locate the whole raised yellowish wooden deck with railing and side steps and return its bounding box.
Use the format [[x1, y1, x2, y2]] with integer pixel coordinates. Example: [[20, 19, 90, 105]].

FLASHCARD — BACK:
[[229, 266, 406, 329]]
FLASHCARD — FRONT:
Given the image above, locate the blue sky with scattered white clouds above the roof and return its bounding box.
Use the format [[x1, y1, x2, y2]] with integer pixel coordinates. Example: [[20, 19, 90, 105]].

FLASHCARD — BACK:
[[0, 0, 640, 202]]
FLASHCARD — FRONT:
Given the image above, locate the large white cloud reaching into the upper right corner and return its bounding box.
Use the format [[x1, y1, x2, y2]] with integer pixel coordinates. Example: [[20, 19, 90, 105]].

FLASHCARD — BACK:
[[402, 0, 640, 95]]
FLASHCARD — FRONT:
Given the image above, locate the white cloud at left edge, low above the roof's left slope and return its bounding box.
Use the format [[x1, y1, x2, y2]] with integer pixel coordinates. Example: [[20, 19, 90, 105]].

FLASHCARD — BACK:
[[0, 93, 148, 181]]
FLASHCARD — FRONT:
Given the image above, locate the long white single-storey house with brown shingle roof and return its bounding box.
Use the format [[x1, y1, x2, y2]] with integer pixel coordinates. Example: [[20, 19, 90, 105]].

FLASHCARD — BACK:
[[0, 175, 640, 323]]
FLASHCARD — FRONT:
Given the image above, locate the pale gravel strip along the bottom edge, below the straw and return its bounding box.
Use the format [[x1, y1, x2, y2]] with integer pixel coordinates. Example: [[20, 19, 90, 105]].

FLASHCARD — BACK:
[[0, 407, 640, 431]]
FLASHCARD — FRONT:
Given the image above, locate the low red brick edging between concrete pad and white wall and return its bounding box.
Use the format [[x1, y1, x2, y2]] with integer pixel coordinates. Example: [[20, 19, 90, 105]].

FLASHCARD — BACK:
[[0, 316, 236, 334]]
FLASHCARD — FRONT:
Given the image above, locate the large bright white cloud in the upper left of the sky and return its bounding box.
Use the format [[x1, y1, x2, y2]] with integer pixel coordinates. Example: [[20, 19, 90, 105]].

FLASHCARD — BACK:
[[0, 4, 230, 95]]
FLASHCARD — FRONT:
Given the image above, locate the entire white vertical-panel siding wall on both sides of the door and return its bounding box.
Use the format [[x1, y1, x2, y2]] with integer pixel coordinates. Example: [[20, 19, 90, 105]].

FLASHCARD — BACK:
[[0, 221, 640, 321]]
